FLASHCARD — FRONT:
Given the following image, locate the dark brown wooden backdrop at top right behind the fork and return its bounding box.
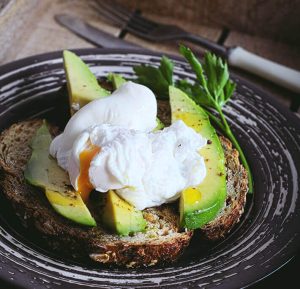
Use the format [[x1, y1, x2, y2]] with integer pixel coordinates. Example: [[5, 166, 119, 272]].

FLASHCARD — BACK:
[[115, 0, 300, 46]]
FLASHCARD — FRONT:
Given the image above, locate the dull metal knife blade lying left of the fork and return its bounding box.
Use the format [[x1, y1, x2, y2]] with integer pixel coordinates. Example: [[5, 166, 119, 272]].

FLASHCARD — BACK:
[[54, 14, 142, 49]]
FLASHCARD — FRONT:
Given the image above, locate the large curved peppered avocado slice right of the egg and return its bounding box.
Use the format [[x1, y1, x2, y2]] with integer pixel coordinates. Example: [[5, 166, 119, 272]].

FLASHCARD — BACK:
[[169, 86, 226, 229]]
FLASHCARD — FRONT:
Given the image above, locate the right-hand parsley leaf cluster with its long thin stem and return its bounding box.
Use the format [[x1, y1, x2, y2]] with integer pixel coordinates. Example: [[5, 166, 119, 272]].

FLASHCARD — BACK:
[[179, 45, 253, 193]]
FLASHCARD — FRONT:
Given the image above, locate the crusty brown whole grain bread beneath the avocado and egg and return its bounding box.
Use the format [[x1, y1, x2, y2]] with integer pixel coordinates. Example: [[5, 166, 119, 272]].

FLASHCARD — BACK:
[[0, 120, 247, 267]]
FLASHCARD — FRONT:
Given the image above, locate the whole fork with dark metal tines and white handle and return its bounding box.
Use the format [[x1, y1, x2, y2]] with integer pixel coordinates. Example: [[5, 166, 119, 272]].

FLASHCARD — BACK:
[[94, 0, 300, 93]]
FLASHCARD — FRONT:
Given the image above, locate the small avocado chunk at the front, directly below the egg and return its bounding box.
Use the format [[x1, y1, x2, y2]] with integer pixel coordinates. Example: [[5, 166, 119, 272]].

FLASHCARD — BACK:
[[102, 190, 146, 235]]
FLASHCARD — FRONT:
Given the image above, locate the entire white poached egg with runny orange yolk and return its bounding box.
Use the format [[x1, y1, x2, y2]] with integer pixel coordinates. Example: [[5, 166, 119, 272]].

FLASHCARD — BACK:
[[50, 82, 206, 210]]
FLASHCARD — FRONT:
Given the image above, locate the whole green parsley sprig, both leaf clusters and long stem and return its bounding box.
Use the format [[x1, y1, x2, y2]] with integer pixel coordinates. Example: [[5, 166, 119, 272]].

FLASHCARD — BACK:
[[134, 45, 253, 193]]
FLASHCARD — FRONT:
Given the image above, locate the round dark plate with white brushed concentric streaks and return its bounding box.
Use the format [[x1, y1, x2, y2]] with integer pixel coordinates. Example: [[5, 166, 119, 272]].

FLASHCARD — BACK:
[[0, 49, 300, 289]]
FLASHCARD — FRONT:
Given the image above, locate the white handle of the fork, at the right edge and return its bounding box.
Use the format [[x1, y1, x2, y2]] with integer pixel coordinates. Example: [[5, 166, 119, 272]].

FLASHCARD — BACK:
[[228, 46, 300, 93]]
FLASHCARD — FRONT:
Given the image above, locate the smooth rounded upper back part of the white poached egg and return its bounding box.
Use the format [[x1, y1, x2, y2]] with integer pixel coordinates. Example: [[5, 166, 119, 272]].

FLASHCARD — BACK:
[[50, 81, 157, 170]]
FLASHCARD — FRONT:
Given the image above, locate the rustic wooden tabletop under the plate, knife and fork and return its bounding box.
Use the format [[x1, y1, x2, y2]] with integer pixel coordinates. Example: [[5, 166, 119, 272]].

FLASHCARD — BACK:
[[0, 0, 300, 289]]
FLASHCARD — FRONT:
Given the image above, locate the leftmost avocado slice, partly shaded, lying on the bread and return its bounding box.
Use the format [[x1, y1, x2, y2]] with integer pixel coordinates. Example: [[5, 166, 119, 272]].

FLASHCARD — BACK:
[[24, 122, 96, 226]]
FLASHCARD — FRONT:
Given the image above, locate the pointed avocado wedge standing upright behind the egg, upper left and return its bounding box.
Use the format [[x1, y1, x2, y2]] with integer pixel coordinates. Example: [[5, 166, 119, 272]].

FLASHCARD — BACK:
[[63, 50, 110, 113]]
